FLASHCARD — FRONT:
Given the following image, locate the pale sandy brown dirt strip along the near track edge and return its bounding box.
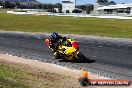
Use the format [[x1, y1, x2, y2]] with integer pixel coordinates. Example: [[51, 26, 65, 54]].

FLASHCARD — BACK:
[[0, 54, 131, 88]]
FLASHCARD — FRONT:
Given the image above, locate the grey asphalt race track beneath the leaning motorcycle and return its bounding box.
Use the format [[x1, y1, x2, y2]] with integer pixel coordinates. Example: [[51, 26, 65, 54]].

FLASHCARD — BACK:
[[0, 32, 132, 80]]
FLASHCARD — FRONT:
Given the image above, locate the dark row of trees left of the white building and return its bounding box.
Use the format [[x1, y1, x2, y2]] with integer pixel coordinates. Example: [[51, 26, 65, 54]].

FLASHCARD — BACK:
[[0, 1, 62, 10]]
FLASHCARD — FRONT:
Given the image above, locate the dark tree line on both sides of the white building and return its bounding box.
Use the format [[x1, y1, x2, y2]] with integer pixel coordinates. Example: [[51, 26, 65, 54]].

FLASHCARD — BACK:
[[0, 1, 93, 13]]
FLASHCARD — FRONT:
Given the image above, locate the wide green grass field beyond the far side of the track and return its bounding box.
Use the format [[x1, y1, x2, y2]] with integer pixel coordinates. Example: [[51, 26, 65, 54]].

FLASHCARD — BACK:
[[0, 14, 132, 38]]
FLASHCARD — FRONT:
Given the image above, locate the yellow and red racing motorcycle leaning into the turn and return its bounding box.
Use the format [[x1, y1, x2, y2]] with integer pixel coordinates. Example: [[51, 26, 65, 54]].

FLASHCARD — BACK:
[[45, 38, 87, 61]]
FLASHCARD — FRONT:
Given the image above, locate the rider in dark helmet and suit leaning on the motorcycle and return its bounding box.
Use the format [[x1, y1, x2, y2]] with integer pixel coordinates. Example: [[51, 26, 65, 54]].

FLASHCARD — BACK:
[[50, 32, 66, 58]]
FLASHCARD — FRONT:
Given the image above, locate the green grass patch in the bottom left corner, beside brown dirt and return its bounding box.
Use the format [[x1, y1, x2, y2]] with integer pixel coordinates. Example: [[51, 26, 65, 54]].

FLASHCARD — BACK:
[[0, 64, 30, 88]]
